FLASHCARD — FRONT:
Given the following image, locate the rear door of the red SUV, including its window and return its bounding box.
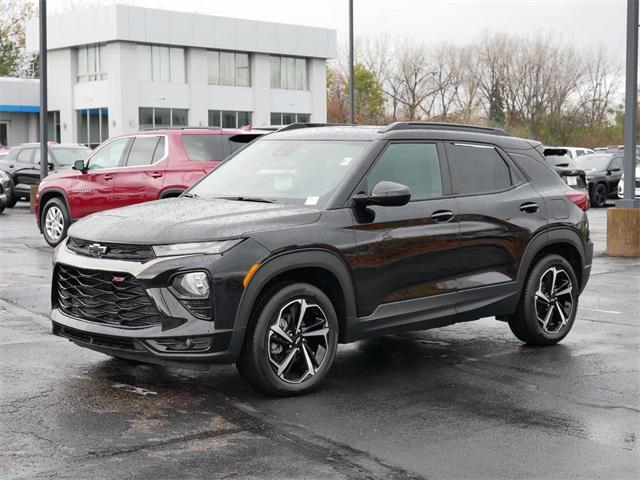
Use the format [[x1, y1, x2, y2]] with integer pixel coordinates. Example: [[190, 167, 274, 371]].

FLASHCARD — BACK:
[[113, 135, 167, 207]]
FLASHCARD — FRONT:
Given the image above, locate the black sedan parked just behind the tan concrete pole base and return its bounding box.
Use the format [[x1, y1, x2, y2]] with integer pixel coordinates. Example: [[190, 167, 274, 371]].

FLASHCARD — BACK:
[[577, 153, 623, 207]]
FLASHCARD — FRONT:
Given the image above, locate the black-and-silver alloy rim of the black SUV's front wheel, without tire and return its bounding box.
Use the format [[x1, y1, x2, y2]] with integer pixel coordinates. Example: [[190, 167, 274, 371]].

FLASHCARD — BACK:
[[267, 298, 329, 384]]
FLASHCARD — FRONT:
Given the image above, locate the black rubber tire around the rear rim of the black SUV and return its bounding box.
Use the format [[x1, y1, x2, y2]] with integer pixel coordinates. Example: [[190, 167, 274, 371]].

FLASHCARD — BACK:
[[511, 255, 580, 345]]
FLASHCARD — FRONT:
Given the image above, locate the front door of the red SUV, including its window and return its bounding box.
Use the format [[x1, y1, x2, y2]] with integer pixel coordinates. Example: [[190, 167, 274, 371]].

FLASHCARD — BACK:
[[67, 137, 130, 218]]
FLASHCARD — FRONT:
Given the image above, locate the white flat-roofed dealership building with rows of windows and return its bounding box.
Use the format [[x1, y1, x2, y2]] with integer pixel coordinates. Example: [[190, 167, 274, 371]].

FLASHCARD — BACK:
[[0, 5, 336, 147]]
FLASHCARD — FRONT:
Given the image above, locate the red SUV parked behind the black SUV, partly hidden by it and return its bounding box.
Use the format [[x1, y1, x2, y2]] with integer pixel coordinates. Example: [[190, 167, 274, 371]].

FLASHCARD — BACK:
[[36, 128, 264, 246]]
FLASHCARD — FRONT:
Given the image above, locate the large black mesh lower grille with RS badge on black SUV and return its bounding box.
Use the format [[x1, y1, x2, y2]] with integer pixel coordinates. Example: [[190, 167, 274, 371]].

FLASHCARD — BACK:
[[54, 265, 162, 328]]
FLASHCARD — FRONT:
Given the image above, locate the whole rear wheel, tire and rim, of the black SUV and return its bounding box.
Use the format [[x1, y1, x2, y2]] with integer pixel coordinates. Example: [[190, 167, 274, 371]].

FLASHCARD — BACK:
[[509, 255, 579, 345]]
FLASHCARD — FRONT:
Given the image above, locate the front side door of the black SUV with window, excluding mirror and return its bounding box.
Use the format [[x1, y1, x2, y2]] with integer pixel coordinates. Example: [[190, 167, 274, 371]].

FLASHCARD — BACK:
[[354, 142, 459, 336]]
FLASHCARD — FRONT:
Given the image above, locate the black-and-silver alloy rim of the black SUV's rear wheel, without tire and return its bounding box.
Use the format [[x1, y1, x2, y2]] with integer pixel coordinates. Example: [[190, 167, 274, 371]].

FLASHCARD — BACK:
[[534, 266, 574, 335]]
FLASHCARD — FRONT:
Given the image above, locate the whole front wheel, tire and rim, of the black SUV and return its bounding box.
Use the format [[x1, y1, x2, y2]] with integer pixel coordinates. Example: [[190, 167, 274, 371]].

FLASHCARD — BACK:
[[237, 283, 338, 396]]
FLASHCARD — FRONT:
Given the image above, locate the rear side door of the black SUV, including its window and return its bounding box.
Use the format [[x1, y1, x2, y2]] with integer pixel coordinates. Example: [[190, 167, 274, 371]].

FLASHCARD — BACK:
[[446, 142, 547, 320]]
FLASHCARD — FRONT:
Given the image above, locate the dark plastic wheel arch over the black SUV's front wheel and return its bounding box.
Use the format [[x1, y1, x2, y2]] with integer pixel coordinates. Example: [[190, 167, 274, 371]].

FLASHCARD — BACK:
[[235, 249, 356, 342]]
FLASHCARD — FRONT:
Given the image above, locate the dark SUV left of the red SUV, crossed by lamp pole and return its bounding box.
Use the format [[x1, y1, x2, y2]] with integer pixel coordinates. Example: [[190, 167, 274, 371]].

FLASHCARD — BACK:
[[0, 142, 91, 207]]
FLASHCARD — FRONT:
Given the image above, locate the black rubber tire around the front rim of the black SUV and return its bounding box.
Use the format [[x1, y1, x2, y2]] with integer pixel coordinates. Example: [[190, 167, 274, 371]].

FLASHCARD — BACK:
[[239, 283, 338, 396]]
